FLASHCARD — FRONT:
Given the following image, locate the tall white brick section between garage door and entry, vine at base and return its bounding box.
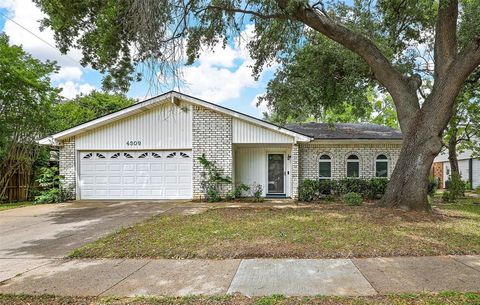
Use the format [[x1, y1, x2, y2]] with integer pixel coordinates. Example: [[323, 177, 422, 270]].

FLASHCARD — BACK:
[[192, 106, 233, 199]]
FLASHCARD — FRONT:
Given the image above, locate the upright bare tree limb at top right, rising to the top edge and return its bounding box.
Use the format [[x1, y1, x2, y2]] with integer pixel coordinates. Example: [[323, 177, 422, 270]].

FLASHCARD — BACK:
[[434, 0, 458, 79]]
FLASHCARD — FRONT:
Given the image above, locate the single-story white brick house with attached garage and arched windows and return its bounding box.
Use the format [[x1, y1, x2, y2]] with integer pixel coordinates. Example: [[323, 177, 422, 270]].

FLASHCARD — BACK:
[[40, 91, 402, 199]]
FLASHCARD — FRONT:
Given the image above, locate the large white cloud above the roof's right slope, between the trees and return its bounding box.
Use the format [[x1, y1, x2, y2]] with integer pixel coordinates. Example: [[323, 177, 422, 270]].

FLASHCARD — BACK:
[[183, 25, 274, 103]]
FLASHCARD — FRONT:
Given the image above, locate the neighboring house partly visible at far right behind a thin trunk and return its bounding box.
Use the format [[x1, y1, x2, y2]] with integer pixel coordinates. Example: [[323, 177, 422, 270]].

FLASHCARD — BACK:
[[432, 150, 480, 189]]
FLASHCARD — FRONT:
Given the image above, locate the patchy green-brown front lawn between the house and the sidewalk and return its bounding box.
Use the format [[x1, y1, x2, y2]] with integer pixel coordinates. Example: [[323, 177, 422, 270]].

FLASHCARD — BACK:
[[70, 200, 480, 259]]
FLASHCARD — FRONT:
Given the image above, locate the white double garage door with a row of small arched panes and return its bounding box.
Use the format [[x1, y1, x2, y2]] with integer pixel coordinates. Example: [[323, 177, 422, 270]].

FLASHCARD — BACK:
[[79, 151, 192, 199]]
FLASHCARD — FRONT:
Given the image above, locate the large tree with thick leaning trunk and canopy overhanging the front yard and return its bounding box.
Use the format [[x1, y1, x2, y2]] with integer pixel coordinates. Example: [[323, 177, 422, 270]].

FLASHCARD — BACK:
[[35, 0, 480, 210]]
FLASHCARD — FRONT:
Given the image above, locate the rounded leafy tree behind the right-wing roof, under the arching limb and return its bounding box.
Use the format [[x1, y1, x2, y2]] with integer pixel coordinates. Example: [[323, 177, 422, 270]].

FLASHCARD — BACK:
[[258, 34, 398, 128]]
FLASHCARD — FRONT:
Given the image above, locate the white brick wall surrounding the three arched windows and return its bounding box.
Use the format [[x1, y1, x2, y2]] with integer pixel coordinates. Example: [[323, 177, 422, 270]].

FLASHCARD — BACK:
[[299, 143, 401, 181]]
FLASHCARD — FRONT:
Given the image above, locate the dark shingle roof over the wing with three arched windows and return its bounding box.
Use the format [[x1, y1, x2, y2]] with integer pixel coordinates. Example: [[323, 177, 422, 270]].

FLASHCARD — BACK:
[[285, 122, 402, 140]]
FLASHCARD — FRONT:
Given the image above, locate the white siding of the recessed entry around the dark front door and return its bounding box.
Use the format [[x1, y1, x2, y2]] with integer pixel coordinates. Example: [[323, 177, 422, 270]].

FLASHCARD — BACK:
[[234, 146, 292, 196]]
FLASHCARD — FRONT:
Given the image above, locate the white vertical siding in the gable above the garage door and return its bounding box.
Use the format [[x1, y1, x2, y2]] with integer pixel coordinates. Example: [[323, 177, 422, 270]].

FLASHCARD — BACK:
[[75, 103, 192, 150]]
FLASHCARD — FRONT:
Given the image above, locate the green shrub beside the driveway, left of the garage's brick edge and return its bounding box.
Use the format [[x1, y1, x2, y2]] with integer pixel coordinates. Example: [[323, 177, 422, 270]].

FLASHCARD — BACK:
[[35, 167, 73, 203]]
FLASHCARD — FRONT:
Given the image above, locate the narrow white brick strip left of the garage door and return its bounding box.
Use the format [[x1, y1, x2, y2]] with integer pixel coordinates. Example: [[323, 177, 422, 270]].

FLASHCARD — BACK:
[[58, 138, 76, 194]]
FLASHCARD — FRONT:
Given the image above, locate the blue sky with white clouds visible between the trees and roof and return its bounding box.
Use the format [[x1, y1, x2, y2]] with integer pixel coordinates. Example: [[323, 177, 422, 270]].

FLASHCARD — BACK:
[[0, 0, 275, 118]]
